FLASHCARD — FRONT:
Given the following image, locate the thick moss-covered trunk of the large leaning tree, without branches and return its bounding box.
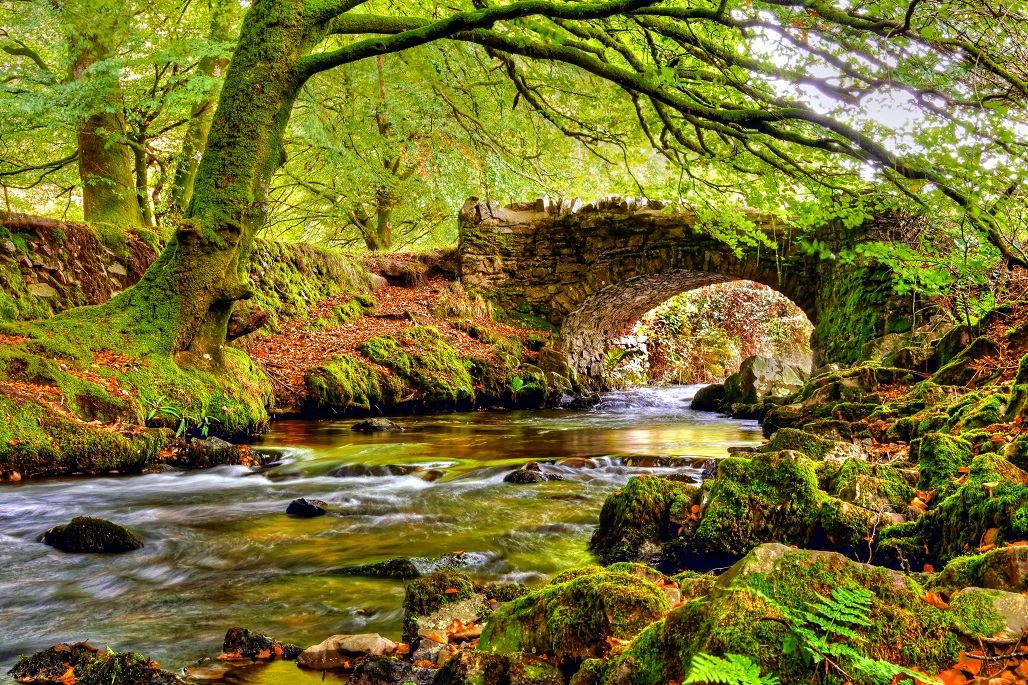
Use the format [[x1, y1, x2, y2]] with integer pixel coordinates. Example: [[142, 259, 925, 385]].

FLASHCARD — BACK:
[[118, 0, 323, 367]]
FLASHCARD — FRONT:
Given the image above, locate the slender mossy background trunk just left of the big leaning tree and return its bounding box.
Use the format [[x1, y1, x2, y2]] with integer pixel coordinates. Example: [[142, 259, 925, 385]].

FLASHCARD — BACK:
[[172, 0, 237, 216]]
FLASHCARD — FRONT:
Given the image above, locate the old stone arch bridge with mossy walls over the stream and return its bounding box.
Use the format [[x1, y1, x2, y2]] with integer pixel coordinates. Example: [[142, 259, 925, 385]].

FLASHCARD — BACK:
[[458, 197, 911, 378]]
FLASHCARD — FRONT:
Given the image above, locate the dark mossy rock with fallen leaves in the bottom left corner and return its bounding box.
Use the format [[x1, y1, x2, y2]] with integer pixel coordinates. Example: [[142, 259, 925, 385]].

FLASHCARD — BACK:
[[8, 643, 185, 685]]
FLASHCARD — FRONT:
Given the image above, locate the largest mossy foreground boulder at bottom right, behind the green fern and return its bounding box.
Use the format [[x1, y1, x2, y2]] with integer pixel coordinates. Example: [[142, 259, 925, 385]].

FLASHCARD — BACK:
[[600, 544, 1007, 685]]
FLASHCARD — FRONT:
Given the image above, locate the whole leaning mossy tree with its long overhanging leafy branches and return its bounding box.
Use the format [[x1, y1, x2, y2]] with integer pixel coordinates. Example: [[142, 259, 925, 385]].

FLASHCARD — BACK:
[[14, 0, 1028, 380]]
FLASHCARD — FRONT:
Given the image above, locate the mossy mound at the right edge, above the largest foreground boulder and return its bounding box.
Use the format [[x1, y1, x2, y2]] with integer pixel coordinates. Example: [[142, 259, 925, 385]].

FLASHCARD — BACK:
[[879, 455, 1028, 570]]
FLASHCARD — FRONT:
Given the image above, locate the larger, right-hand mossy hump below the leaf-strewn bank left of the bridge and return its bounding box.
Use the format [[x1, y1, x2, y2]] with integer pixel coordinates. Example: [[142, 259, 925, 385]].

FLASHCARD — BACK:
[[358, 326, 475, 407]]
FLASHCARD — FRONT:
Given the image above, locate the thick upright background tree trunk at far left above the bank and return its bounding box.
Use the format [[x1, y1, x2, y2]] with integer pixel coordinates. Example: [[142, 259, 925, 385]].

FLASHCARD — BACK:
[[71, 13, 143, 228]]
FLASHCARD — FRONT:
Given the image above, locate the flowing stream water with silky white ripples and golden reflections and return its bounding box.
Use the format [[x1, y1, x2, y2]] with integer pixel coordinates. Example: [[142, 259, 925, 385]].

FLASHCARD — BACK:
[[0, 387, 760, 685]]
